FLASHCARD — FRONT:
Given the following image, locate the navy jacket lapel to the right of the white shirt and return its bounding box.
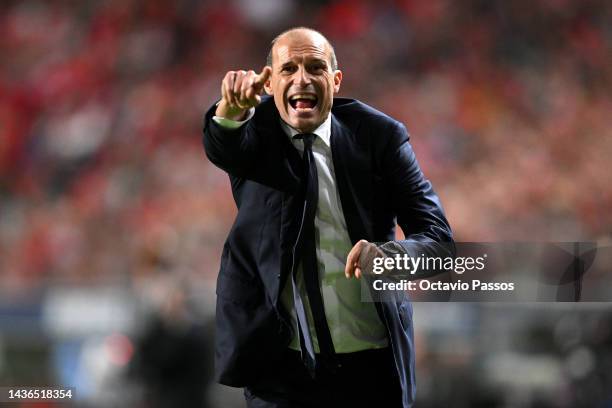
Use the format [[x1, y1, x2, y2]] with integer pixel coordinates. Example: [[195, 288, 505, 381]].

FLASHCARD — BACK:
[[331, 115, 374, 244]]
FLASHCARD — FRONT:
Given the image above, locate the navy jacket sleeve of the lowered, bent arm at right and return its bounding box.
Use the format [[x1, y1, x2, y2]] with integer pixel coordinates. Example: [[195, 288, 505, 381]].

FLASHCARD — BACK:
[[383, 122, 455, 268]]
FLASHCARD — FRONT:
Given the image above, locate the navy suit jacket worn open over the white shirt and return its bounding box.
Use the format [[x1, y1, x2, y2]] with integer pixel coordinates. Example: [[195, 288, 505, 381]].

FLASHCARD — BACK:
[[203, 97, 452, 407]]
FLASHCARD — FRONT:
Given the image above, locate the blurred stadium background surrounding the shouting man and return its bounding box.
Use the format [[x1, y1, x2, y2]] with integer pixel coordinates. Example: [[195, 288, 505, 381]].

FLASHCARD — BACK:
[[0, 0, 612, 407]]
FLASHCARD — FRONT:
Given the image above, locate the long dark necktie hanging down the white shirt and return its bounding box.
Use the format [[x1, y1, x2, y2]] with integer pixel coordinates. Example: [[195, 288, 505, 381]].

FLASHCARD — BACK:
[[291, 133, 336, 377]]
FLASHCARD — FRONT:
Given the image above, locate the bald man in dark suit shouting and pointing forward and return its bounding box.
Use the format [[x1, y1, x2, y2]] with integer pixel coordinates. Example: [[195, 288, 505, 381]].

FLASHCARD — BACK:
[[204, 28, 452, 407]]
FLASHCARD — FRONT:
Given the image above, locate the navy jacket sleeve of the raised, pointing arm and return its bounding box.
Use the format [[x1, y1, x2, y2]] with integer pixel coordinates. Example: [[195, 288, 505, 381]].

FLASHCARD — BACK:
[[202, 105, 260, 177]]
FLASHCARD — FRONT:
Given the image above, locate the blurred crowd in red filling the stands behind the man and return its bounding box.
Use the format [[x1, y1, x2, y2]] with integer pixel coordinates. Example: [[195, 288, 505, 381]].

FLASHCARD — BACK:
[[0, 0, 612, 294]]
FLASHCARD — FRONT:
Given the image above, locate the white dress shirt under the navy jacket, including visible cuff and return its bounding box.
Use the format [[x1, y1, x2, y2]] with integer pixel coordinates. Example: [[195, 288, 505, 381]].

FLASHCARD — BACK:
[[213, 109, 388, 353]]
